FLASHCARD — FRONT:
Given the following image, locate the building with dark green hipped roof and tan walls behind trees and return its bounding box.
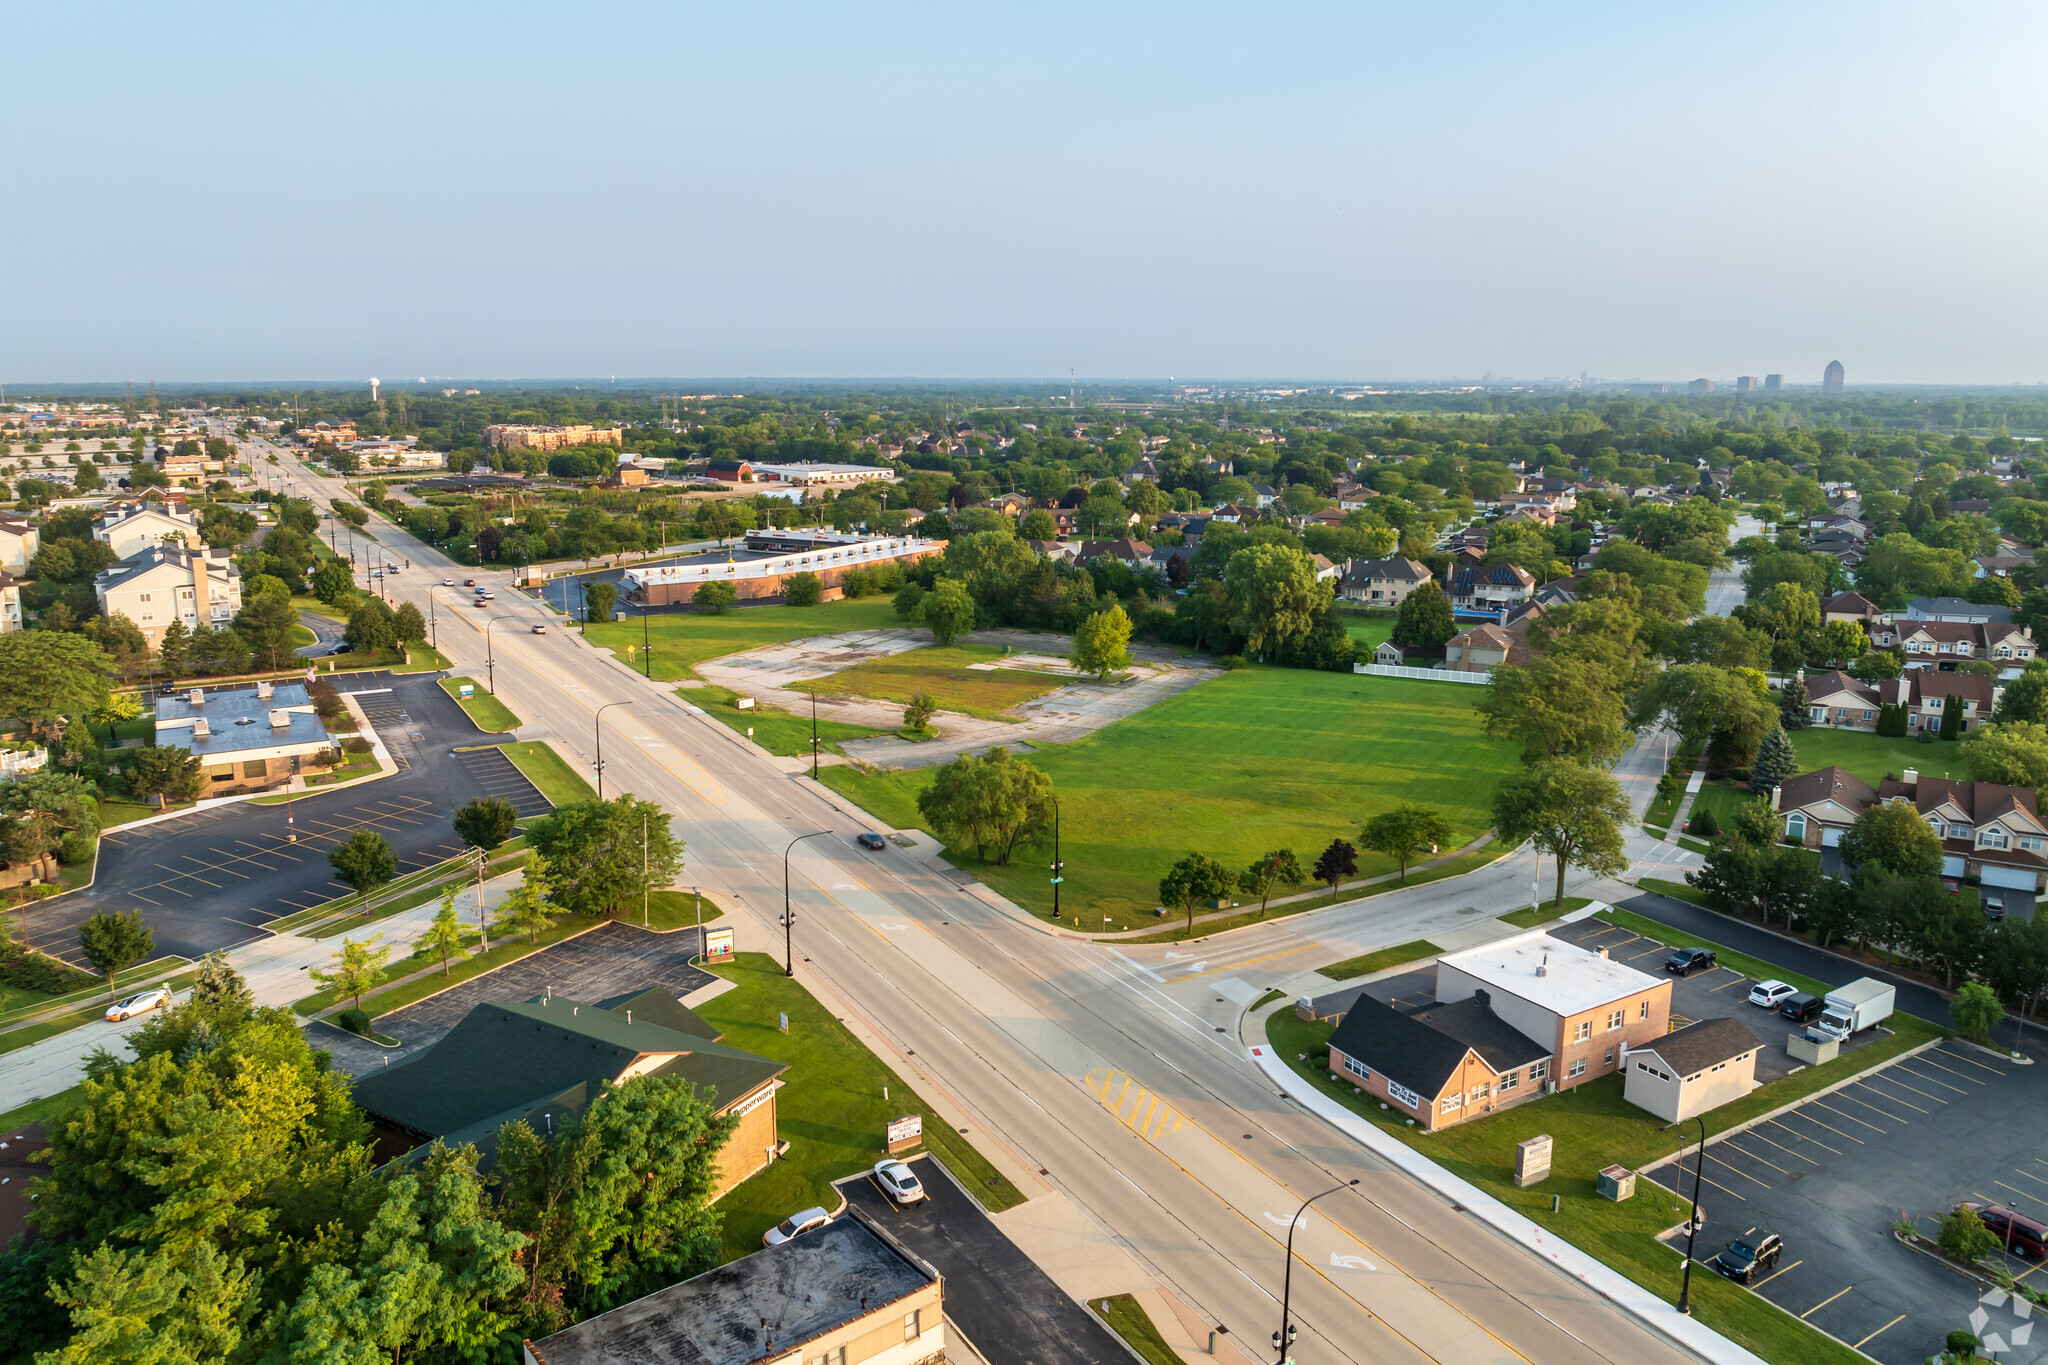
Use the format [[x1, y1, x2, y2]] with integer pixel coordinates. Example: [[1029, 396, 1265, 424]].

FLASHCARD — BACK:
[[352, 986, 788, 1199]]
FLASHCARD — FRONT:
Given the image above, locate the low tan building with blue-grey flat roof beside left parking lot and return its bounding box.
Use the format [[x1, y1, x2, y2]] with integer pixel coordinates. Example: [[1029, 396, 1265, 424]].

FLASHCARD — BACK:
[[156, 684, 340, 796]]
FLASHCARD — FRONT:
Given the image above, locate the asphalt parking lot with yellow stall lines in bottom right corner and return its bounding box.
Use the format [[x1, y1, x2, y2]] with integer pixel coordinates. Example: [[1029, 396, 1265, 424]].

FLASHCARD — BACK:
[[1657, 1042, 2048, 1365]]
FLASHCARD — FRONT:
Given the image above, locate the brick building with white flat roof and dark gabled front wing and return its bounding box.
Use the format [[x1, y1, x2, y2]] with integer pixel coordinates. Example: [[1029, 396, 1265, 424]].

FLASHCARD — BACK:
[[1329, 929, 1671, 1130]]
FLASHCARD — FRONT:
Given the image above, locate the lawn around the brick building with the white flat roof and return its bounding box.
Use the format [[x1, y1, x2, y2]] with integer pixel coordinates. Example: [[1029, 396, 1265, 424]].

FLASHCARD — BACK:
[[1266, 998, 1939, 1365]]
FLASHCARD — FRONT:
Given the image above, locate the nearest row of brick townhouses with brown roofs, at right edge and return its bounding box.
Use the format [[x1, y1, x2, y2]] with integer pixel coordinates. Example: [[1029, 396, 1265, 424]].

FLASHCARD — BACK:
[[1772, 767, 2048, 913]]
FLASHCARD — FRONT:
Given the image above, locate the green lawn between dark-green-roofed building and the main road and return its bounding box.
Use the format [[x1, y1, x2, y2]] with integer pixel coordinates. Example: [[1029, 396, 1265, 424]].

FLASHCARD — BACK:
[[696, 954, 1024, 1261]]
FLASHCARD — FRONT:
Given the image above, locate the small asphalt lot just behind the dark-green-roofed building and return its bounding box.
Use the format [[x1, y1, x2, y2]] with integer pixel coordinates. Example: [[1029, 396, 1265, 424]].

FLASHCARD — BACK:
[[313, 929, 717, 1076]]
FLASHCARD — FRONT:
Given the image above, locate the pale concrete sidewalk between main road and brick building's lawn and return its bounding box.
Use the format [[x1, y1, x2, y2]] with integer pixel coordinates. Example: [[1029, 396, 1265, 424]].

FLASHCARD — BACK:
[[1251, 1044, 1767, 1365]]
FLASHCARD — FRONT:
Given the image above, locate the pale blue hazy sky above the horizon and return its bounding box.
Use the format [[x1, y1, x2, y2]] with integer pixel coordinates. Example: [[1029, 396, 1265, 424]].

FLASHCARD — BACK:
[[16, 0, 2048, 387]]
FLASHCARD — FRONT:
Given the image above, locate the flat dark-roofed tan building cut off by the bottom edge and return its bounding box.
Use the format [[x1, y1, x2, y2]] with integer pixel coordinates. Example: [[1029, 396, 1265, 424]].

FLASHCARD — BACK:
[[528, 1203, 946, 1365]]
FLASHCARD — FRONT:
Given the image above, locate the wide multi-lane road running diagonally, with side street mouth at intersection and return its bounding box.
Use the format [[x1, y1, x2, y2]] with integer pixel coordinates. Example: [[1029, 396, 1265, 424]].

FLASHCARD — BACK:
[[211, 442, 1694, 1365]]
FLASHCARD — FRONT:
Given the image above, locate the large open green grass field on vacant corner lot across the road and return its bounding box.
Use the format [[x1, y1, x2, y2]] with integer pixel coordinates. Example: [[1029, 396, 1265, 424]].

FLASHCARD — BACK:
[[821, 667, 1520, 929]]
